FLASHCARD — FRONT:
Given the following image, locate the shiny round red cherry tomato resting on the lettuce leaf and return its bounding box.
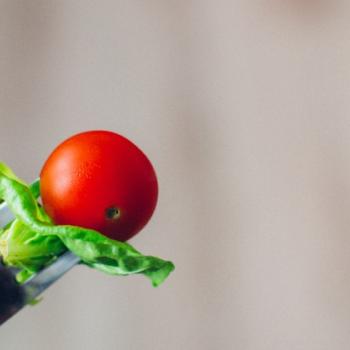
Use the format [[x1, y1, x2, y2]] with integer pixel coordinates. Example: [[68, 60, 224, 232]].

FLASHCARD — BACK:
[[40, 130, 158, 241]]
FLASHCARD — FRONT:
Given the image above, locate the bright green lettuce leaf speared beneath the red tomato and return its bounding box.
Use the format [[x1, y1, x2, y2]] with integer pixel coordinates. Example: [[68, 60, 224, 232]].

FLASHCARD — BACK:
[[0, 163, 175, 286]]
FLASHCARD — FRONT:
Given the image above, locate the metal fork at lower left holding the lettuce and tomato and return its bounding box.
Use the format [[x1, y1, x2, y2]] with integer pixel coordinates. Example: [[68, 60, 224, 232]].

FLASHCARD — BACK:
[[0, 203, 79, 325]]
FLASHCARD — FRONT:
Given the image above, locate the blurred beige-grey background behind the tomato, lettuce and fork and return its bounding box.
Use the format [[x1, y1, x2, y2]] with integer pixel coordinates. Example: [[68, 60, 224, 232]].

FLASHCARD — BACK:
[[0, 0, 350, 350]]
